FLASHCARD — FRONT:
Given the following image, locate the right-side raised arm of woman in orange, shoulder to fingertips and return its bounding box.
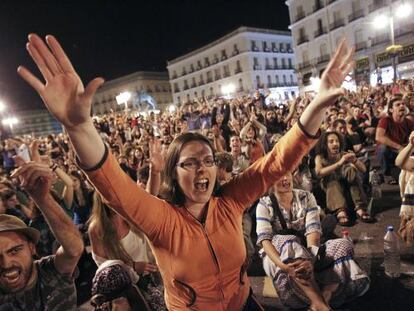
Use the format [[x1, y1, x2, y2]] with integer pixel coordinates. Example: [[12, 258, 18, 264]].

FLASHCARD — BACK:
[[223, 41, 353, 210]]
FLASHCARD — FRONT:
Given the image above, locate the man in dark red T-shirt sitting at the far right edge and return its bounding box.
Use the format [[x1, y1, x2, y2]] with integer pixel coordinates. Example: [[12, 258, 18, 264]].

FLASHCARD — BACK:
[[375, 96, 414, 184]]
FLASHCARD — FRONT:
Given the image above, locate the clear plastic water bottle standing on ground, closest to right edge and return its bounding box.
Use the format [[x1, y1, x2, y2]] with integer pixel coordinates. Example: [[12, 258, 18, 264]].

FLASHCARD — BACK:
[[384, 226, 401, 278]]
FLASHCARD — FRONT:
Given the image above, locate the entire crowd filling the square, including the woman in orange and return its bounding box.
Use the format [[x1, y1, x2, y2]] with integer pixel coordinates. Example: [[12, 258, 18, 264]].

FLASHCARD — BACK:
[[0, 35, 414, 310]]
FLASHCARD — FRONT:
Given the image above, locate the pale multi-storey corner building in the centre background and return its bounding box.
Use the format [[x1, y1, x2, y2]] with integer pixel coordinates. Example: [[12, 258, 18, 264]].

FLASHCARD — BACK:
[[167, 27, 298, 104]]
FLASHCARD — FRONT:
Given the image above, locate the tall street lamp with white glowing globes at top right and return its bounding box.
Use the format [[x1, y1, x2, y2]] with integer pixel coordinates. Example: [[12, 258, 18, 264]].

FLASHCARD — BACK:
[[374, 3, 411, 82]]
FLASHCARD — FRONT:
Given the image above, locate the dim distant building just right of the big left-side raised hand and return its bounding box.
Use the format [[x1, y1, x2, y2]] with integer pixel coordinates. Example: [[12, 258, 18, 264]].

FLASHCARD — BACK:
[[93, 71, 172, 115]]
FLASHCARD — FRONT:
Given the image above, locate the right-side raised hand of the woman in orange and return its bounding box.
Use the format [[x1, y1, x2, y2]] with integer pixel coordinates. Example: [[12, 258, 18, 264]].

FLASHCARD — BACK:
[[317, 39, 354, 107]]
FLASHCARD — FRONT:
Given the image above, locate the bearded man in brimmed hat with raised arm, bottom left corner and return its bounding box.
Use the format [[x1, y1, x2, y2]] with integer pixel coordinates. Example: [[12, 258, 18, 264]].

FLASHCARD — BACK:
[[0, 162, 83, 311]]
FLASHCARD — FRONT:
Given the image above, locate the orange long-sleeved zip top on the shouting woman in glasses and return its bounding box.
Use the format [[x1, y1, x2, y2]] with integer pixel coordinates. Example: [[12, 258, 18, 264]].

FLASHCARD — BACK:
[[85, 125, 316, 311]]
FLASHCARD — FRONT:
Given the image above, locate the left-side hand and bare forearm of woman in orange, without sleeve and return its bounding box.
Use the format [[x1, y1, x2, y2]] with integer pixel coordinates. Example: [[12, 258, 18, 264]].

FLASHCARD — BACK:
[[17, 34, 105, 167]]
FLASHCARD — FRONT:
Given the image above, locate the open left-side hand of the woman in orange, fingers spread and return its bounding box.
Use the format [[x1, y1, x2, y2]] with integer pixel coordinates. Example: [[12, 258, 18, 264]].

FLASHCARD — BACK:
[[17, 34, 104, 129]]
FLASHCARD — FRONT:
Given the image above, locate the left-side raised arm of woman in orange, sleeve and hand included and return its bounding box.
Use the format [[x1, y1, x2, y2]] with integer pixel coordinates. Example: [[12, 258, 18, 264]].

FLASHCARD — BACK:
[[18, 34, 169, 244]]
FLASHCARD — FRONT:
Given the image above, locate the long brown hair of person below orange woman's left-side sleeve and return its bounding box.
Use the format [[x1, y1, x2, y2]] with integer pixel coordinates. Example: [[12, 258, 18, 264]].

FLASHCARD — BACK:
[[88, 191, 133, 264]]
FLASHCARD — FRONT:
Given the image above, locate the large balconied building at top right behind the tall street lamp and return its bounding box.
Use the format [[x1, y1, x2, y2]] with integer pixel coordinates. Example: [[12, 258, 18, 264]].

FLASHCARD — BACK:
[[286, 0, 414, 90]]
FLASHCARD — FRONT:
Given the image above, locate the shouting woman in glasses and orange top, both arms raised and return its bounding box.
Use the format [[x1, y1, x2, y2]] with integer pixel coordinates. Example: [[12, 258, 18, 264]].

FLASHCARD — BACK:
[[18, 34, 353, 310]]
